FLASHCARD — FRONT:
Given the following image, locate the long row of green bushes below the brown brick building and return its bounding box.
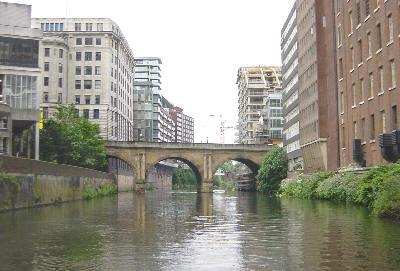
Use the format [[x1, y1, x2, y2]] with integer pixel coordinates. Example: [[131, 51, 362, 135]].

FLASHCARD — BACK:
[[280, 164, 400, 217]]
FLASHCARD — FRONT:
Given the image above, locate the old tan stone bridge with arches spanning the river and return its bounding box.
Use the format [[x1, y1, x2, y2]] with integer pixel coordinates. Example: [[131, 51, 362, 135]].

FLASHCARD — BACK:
[[106, 141, 272, 192]]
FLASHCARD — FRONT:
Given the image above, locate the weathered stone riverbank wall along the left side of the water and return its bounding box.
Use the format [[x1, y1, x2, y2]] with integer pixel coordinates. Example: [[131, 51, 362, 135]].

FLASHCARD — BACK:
[[0, 156, 116, 211]]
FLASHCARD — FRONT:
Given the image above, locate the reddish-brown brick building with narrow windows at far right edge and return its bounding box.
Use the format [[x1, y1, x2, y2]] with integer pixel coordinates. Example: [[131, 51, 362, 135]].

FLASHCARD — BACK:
[[334, 0, 400, 166]]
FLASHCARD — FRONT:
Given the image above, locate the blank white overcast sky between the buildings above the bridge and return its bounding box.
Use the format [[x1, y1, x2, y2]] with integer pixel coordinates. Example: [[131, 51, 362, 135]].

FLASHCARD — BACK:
[[7, 0, 295, 143]]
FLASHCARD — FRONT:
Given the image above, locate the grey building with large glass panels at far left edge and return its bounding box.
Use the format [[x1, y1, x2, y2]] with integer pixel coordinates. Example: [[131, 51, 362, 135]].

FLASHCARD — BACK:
[[0, 2, 42, 159]]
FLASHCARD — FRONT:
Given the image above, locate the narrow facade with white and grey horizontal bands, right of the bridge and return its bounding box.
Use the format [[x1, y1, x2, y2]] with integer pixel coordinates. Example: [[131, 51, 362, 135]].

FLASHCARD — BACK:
[[281, 4, 303, 170]]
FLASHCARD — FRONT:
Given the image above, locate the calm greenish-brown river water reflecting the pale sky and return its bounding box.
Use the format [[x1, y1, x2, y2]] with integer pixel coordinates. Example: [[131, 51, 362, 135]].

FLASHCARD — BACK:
[[0, 191, 400, 270]]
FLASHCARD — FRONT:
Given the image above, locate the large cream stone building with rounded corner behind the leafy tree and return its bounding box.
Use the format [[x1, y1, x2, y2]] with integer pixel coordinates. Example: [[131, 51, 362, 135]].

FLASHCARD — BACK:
[[32, 18, 134, 141]]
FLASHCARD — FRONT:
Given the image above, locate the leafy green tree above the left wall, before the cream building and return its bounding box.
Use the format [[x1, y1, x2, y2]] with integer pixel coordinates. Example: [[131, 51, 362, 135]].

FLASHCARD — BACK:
[[40, 104, 106, 170]]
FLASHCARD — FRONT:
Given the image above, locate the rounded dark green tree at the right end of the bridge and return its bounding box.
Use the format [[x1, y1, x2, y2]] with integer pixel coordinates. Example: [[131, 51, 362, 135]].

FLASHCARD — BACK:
[[256, 146, 288, 194]]
